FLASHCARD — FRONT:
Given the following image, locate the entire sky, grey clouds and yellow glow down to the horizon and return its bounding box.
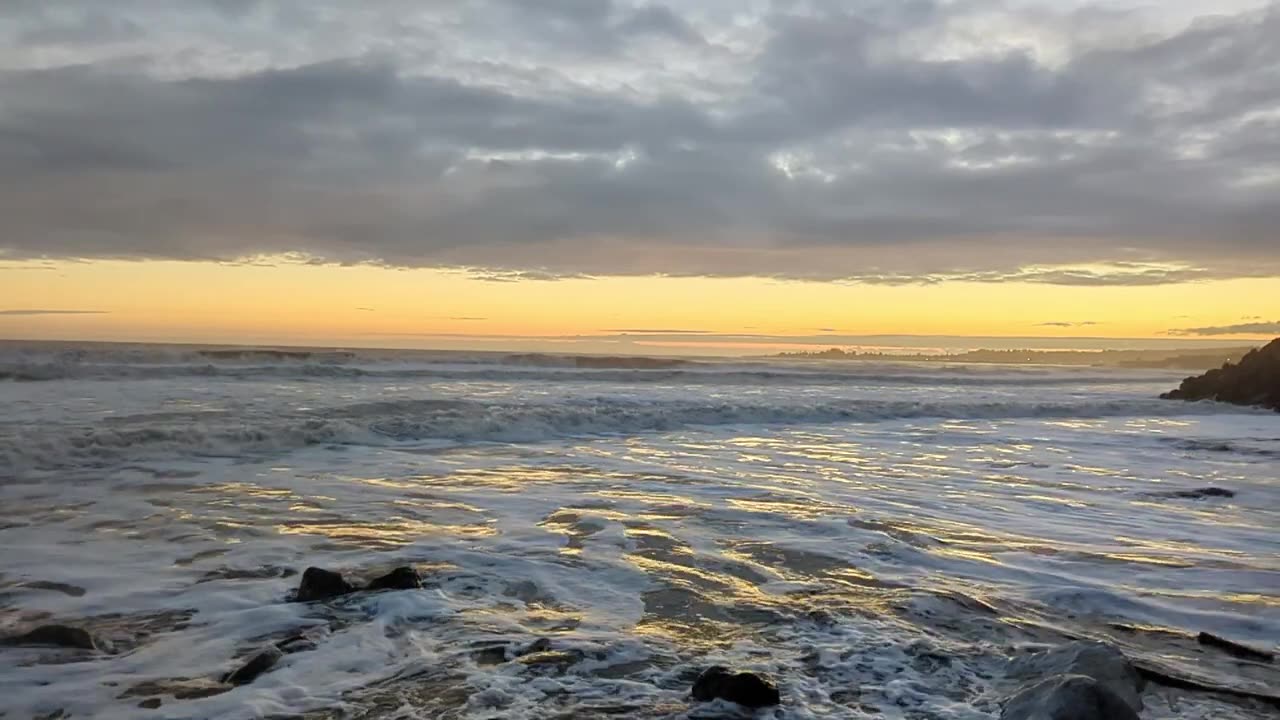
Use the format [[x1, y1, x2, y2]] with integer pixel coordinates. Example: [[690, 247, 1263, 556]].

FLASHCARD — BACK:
[[0, 0, 1280, 352]]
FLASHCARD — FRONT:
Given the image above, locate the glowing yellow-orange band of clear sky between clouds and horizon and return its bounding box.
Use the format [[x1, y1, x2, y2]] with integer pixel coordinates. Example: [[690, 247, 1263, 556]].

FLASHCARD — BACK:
[[0, 260, 1280, 354]]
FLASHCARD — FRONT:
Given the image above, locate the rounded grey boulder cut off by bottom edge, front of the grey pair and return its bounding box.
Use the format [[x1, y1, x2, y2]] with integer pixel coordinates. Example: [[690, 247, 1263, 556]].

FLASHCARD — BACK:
[[1000, 675, 1138, 720]]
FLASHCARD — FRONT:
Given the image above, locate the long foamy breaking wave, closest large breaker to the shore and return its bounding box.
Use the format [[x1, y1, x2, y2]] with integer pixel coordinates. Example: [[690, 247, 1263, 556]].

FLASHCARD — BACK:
[[0, 397, 1249, 477]]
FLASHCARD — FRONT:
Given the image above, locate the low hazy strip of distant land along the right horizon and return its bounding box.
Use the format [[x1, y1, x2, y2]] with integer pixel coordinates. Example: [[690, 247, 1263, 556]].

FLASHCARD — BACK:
[[773, 346, 1253, 370]]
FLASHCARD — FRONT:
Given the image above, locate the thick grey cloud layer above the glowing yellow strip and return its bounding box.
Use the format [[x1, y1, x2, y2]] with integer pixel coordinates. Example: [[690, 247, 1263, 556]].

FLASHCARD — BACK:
[[0, 0, 1280, 286]]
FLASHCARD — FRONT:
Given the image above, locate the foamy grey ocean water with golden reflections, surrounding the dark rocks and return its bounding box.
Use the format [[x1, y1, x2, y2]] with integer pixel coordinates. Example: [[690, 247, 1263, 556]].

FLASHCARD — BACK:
[[0, 342, 1280, 720]]
